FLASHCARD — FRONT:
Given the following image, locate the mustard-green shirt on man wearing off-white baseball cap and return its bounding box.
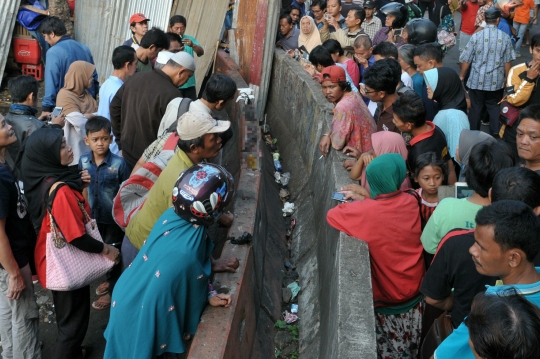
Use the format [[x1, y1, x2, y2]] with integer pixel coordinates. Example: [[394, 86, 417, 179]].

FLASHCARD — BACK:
[[126, 150, 193, 249]]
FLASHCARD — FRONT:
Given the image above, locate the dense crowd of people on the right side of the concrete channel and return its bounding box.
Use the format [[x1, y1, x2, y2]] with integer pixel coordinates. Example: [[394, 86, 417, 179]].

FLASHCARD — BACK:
[[276, 0, 540, 359]]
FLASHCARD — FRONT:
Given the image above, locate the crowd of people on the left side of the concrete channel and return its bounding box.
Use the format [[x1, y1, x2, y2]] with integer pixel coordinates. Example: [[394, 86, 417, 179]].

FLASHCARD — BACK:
[[0, 8, 239, 359]]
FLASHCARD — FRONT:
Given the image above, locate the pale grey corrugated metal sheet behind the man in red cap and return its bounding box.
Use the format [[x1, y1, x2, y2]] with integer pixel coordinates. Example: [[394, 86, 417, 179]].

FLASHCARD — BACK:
[[74, 0, 173, 83]]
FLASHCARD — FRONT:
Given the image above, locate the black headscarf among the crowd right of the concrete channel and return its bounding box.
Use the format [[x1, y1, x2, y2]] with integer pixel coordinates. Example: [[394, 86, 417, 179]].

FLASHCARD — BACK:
[[433, 67, 467, 113]]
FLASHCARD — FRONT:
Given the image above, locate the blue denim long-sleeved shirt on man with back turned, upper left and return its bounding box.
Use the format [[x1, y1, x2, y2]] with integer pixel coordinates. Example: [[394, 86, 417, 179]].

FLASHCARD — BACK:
[[42, 35, 99, 112]]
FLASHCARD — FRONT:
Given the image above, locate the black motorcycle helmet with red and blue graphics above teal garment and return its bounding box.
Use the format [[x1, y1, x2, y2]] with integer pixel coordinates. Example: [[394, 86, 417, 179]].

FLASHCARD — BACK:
[[172, 163, 234, 226]]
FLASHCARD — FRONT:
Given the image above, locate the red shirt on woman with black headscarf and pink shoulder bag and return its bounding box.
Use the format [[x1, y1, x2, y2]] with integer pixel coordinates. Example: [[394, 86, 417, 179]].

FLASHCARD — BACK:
[[34, 186, 91, 288]]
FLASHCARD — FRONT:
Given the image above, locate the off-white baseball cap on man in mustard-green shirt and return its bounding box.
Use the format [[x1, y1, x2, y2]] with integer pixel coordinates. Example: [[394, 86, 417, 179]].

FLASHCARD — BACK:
[[176, 112, 231, 141]]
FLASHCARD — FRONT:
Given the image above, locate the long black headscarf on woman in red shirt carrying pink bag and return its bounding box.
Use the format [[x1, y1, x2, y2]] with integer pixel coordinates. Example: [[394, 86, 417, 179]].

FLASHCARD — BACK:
[[21, 127, 83, 228]]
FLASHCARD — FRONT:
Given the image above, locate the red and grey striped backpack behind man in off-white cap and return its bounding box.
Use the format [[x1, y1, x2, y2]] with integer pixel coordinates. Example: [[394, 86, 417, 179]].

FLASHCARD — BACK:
[[112, 98, 191, 228]]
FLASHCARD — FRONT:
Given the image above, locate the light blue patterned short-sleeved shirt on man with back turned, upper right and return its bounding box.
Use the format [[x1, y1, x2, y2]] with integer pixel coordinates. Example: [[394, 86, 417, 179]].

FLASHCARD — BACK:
[[459, 25, 516, 91]]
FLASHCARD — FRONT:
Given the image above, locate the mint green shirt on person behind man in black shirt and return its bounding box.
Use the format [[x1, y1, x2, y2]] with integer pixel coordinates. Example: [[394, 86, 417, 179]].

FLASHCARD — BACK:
[[420, 198, 482, 254]]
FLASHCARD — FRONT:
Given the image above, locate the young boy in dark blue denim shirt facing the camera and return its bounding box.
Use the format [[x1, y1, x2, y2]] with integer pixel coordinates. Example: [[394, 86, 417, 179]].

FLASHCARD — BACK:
[[79, 116, 131, 310]]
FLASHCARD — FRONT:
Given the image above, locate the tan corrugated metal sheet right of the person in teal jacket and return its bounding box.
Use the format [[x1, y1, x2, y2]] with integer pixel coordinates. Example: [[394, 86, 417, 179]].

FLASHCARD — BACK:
[[176, 0, 228, 92]]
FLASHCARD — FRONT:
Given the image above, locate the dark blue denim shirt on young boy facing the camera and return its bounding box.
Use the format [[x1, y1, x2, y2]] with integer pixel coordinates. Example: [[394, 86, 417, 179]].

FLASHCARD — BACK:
[[79, 151, 131, 224]]
